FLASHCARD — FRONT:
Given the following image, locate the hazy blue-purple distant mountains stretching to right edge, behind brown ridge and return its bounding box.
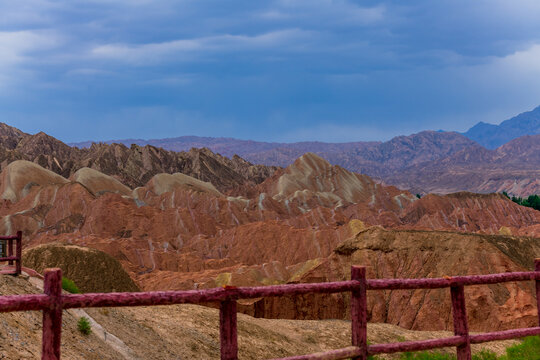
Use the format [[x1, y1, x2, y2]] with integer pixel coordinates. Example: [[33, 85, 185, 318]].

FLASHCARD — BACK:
[[65, 107, 540, 195]]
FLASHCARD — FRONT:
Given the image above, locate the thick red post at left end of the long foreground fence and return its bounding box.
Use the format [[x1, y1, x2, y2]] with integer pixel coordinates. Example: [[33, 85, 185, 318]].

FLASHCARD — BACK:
[[41, 268, 62, 360]]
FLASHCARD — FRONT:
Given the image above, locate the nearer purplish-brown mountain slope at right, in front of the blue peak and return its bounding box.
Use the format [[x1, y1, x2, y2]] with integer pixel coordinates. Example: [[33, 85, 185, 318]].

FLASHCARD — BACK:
[[385, 135, 540, 196]]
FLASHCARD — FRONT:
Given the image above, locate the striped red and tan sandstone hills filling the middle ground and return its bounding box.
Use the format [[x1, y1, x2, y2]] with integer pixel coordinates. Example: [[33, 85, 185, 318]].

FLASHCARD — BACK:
[[0, 136, 540, 329]]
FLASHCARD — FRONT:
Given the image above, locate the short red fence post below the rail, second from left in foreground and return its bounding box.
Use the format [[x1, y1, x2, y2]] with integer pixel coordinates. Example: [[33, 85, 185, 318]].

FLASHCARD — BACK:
[[219, 299, 238, 360]]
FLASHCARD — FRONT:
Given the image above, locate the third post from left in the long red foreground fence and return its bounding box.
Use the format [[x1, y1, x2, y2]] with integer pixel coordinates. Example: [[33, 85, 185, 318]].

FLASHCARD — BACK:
[[351, 266, 368, 360]]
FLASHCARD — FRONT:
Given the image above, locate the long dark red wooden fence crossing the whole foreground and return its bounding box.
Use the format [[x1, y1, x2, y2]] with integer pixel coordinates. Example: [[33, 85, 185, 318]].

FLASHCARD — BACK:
[[0, 250, 540, 360]]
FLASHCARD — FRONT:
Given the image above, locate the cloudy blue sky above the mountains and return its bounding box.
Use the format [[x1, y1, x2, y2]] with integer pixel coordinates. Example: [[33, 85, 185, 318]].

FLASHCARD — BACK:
[[0, 0, 540, 142]]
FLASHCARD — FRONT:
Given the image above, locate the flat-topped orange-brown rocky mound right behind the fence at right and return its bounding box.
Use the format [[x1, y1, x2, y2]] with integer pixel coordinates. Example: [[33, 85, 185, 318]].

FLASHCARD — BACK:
[[254, 227, 540, 331]]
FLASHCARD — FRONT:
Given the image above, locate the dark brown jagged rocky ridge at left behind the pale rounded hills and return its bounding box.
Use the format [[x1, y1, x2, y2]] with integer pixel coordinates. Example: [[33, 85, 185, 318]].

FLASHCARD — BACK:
[[0, 124, 277, 191]]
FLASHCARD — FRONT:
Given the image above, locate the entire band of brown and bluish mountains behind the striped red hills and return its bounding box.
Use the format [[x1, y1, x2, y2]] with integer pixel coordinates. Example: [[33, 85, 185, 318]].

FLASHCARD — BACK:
[[0, 107, 540, 196]]
